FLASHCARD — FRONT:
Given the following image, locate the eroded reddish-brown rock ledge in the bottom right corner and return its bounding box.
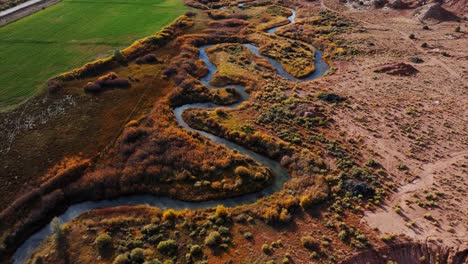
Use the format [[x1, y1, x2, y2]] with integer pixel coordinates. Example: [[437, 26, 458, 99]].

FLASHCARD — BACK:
[[341, 243, 468, 264]]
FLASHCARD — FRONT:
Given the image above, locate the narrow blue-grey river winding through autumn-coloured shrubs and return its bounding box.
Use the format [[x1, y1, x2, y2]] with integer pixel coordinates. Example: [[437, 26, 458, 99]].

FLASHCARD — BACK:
[[12, 9, 328, 264]]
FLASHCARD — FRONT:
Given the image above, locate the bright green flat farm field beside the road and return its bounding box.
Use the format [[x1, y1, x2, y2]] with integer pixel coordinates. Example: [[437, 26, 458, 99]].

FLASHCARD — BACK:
[[0, 0, 186, 110]]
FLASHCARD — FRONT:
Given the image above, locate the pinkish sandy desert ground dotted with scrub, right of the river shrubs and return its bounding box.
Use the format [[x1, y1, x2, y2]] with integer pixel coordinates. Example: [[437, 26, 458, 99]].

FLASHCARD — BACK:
[[308, 0, 468, 248]]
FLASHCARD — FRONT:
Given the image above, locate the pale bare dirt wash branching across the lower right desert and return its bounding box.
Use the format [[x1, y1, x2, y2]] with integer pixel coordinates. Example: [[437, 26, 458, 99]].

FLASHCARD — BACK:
[[363, 150, 468, 247]]
